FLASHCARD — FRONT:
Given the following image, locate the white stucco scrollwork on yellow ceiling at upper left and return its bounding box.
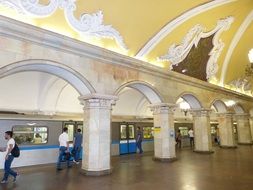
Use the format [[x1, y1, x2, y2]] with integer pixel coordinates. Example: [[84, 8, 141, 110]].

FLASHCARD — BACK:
[[0, 0, 127, 50]]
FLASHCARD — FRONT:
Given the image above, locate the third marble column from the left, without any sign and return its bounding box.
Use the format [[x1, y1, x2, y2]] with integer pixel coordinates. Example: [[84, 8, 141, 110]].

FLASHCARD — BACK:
[[191, 109, 214, 154]]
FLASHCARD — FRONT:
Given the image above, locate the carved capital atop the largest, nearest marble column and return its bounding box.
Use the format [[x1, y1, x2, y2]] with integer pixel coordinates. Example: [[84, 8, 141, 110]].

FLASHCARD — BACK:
[[78, 93, 118, 109]]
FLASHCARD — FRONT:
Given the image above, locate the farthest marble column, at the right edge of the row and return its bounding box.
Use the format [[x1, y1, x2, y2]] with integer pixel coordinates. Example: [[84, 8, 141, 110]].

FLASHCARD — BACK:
[[235, 114, 252, 145]]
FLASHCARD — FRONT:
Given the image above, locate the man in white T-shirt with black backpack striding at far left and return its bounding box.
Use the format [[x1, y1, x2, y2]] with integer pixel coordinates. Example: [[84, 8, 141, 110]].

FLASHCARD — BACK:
[[0, 131, 20, 183]]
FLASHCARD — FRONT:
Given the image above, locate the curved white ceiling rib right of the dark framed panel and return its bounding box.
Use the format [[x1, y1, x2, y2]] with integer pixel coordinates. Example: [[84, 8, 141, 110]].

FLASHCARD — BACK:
[[220, 10, 253, 85]]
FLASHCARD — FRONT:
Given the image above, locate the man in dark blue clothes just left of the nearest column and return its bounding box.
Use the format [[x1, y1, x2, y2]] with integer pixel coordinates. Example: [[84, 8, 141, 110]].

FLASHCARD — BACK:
[[73, 129, 83, 164]]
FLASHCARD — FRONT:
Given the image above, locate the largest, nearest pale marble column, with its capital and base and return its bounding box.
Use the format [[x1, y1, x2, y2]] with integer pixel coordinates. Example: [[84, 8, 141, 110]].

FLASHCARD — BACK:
[[79, 94, 117, 176]]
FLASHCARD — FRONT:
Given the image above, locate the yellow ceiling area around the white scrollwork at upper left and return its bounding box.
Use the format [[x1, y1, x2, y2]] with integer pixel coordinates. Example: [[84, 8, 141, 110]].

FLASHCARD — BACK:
[[1, 0, 210, 55]]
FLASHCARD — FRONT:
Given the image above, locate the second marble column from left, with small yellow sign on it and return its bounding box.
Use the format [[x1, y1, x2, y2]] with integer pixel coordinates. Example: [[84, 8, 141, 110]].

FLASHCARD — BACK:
[[151, 103, 176, 162]]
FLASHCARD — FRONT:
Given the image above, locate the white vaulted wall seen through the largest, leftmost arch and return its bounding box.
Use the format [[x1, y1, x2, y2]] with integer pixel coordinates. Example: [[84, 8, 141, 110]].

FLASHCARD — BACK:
[[0, 72, 82, 115]]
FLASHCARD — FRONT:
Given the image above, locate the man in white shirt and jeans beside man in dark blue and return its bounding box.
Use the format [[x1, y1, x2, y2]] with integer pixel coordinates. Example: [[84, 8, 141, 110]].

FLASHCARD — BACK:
[[57, 127, 71, 170]]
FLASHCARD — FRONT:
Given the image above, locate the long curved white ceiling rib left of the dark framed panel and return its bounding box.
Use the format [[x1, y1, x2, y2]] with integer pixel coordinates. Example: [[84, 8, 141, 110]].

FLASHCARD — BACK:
[[136, 0, 237, 58]]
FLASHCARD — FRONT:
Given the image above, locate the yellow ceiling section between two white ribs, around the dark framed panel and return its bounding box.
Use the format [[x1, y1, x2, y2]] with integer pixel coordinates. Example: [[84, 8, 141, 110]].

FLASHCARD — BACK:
[[147, 0, 253, 70]]
